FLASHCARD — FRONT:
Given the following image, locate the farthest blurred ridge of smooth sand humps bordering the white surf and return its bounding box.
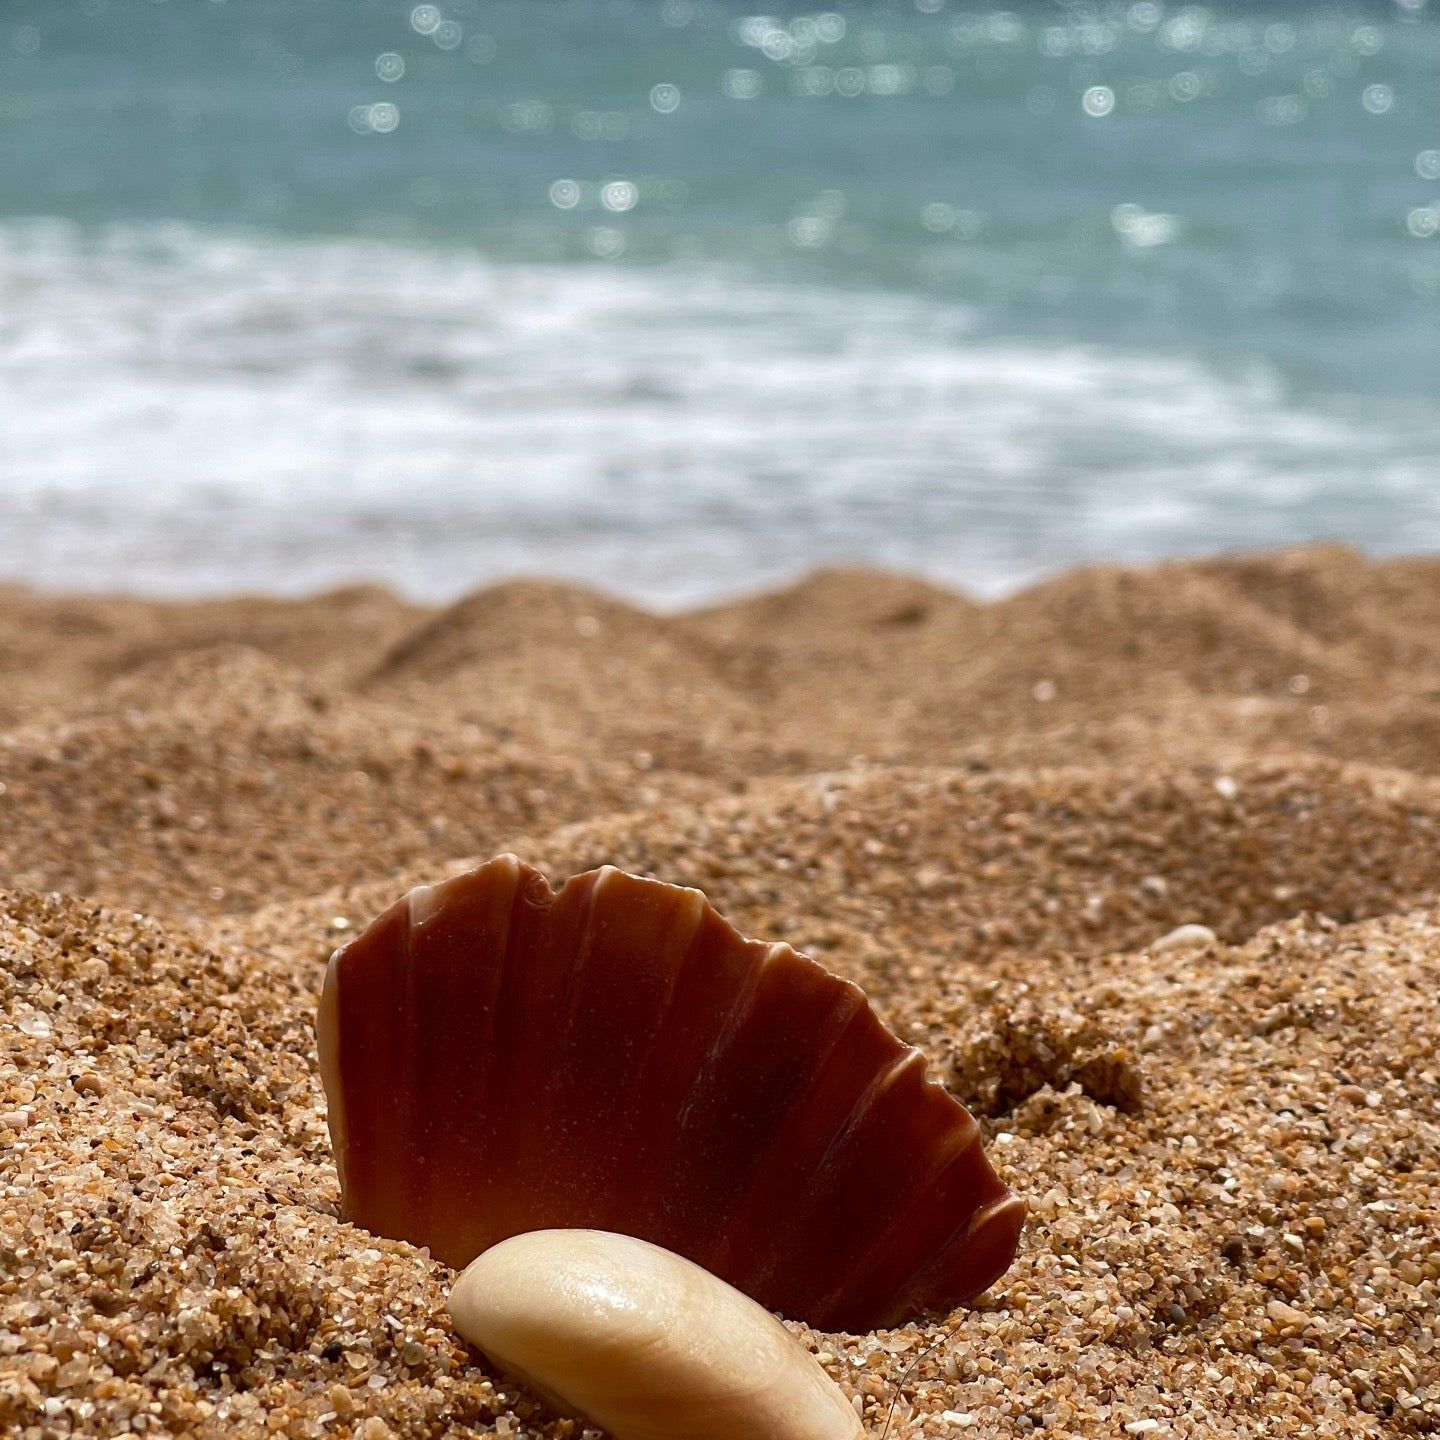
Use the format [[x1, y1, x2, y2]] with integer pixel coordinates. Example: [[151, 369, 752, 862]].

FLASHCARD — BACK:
[[0, 547, 1440, 783]]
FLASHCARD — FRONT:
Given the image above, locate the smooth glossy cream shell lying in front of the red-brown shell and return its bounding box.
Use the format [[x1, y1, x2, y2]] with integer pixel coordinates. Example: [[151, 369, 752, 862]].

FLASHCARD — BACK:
[[449, 1230, 864, 1440]]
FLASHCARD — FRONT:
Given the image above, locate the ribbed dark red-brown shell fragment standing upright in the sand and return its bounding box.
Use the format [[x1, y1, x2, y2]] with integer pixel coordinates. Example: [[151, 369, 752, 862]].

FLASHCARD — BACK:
[[318, 855, 1024, 1331]]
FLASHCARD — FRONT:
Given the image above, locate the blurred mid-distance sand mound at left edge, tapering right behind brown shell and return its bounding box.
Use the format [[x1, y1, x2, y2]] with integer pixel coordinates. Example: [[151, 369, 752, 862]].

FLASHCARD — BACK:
[[0, 648, 717, 914]]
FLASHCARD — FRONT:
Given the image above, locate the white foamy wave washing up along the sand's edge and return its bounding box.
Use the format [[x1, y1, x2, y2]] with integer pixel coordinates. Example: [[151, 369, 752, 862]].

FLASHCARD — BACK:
[[0, 220, 1440, 603]]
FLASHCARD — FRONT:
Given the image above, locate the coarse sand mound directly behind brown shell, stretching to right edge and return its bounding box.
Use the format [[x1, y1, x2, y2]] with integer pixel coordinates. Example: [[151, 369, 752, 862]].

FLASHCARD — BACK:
[[483, 763, 1440, 1002]]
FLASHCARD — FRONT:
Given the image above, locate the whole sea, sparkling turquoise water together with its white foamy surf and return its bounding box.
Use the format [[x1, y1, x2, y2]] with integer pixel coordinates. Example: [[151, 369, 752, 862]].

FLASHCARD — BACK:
[[0, 0, 1440, 602]]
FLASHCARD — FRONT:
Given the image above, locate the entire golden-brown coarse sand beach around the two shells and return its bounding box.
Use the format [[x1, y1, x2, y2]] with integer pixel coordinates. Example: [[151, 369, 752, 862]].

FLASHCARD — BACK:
[[0, 547, 1440, 1440]]
